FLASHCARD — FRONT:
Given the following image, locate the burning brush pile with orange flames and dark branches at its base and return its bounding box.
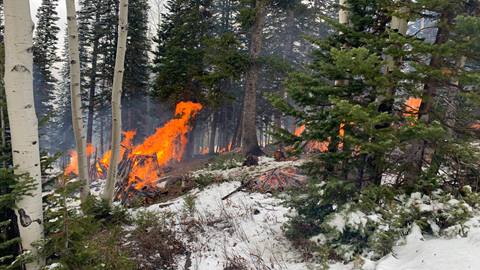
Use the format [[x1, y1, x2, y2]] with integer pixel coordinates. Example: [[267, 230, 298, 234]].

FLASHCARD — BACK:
[[64, 102, 202, 203]]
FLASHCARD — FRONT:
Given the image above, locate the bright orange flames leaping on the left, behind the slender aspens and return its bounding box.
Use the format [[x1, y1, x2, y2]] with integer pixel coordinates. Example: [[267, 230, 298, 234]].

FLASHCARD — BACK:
[[65, 102, 202, 189]]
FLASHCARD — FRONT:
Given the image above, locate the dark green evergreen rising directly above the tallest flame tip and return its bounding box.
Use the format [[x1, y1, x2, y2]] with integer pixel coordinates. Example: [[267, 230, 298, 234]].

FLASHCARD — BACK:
[[152, 0, 211, 102]]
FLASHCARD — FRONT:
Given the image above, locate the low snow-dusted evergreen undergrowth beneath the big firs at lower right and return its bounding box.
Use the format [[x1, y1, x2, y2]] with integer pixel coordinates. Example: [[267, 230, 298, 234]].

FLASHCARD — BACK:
[[284, 181, 480, 266]]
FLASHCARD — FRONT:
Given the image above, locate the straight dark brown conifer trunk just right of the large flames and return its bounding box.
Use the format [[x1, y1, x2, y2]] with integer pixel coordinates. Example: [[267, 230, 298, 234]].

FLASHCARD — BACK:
[[242, 0, 267, 155]]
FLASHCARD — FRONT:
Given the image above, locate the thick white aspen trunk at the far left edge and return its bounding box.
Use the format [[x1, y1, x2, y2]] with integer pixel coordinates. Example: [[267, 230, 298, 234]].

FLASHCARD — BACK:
[[4, 0, 45, 270]]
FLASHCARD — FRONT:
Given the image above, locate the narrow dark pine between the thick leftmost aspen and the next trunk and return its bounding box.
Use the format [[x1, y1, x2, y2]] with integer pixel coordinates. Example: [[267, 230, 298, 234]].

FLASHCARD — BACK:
[[33, 0, 60, 150]]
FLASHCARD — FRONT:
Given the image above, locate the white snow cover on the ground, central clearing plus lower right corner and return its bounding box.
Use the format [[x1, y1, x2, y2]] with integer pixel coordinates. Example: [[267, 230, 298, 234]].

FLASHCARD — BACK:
[[133, 158, 480, 270]]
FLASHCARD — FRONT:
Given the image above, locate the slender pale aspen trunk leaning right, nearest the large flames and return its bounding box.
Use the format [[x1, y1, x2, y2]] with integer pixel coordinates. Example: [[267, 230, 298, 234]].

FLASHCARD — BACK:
[[102, 0, 128, 203]]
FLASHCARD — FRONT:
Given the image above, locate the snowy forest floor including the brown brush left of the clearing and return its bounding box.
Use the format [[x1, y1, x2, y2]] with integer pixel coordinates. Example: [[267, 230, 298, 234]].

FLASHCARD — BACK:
[[71, 154, 480, 270]]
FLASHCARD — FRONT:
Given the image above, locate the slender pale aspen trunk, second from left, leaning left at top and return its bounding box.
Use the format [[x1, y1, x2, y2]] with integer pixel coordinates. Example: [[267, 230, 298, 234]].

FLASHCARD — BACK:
[[65, 0, 90, 201]]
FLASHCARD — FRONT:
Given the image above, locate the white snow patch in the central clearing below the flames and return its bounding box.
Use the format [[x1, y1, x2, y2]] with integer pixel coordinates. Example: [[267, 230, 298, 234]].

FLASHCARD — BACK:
[[136, 181, 314, 270]]
